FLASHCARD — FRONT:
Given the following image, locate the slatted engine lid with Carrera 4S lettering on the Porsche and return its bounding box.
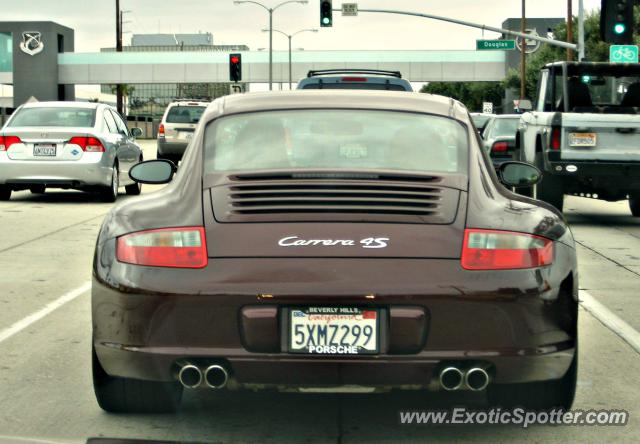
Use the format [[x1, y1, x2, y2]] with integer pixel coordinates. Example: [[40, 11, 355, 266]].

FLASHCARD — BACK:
[[203, 171, 467, 259]]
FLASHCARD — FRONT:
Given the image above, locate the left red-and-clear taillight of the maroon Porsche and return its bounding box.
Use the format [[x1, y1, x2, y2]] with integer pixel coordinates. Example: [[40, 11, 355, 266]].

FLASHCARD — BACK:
[[116, 227, 207, 268]]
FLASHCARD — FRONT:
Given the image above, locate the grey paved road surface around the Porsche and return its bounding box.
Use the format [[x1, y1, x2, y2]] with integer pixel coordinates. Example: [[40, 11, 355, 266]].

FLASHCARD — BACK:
[[0, 142, 640, 443]]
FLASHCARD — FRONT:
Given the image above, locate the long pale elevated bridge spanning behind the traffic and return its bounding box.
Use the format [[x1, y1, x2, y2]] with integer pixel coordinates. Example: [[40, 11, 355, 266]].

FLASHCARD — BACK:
[[58, 50, 506, 85]]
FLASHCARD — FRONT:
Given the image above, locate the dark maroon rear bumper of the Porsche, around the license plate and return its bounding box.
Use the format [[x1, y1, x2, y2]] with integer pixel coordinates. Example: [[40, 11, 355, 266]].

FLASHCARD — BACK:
[[92, 246, 577, 387]]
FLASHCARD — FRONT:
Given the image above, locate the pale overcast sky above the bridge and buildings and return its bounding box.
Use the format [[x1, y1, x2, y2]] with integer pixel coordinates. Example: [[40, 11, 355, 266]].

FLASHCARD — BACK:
[[0, 0, 600, 52]]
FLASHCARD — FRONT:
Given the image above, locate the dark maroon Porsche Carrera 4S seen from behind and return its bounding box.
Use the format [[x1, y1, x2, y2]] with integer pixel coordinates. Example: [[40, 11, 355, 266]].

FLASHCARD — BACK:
[[92, 91, 578, 412]]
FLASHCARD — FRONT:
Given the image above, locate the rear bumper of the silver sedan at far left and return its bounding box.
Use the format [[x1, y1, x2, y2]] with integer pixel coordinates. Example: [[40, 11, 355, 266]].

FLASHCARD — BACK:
[[0, 152, 112, 188]]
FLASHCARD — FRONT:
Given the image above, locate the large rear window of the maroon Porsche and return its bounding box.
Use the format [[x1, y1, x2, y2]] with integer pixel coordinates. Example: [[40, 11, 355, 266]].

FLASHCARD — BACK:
[[205, 109, 468, 173]]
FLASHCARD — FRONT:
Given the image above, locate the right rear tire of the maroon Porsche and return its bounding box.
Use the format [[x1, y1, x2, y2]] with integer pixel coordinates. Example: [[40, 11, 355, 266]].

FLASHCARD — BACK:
[[487, 342, 578, 410]]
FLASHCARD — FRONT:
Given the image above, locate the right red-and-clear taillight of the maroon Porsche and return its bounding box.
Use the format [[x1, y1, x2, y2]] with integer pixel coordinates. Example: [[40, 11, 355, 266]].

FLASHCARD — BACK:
[[461, 229, 553, 270]]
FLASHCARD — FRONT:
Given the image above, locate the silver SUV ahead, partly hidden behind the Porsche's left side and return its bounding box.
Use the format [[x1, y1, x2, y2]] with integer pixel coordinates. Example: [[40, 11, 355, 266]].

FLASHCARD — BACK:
[[158, 100, 209, 163]]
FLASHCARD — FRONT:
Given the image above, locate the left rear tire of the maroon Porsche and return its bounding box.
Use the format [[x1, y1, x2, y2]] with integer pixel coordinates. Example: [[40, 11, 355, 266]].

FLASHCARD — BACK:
[[91, 347, 182, 413]]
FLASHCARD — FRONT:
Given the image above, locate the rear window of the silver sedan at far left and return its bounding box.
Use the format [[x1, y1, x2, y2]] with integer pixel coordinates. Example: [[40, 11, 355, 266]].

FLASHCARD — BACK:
[[8, 107, 96, 128]]
